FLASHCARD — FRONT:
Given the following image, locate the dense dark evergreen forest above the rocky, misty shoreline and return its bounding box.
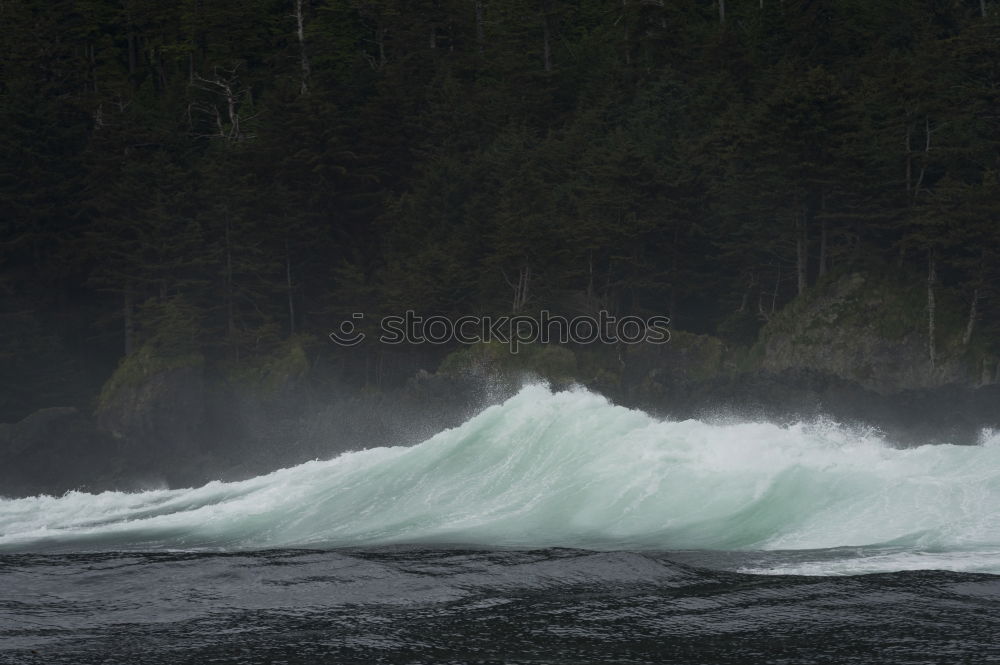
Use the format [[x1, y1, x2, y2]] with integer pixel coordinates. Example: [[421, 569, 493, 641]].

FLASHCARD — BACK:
[[0, 0, 1000, 421]]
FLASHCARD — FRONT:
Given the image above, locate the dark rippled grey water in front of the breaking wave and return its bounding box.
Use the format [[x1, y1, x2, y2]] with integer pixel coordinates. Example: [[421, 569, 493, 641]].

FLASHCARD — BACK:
[[0, 547, 1000, 665]]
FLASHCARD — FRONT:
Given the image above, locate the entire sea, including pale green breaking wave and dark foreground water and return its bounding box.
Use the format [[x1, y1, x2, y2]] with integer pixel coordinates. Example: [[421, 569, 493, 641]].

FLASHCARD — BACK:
[[0, 385, 1000, 664]]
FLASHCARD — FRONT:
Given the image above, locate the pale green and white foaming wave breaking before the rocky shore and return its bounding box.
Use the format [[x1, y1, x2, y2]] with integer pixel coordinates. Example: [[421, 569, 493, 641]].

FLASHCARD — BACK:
[[0, 385, 1000, 575]]
